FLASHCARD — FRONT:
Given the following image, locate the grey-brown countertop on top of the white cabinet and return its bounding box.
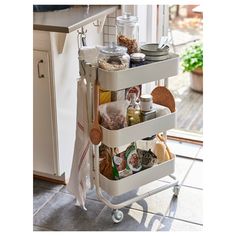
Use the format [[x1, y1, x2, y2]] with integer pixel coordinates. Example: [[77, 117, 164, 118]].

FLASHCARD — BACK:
[[33, 5, 119, 33]]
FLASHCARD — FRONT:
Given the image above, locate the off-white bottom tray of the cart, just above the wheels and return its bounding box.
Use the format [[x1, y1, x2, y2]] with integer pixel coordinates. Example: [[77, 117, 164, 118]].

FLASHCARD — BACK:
[[99, 154, 175, 196]]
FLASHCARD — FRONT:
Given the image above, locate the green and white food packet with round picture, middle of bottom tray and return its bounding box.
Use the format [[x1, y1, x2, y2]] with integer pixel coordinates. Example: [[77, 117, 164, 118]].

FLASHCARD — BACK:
[[125, 142, 142, 173]]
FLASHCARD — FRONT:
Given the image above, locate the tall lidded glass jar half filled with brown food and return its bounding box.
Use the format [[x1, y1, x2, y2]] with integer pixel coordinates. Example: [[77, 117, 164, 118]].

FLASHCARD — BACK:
[[116, 13, 139, 54]]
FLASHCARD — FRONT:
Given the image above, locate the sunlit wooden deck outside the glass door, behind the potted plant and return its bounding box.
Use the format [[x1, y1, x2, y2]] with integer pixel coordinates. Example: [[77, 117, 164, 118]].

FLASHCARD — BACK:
[[168, 15, 203, 134]]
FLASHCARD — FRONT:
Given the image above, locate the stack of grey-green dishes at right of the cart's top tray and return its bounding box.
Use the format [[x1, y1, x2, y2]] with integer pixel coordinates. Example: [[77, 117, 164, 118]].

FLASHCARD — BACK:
[[140, 43, 169, 61]]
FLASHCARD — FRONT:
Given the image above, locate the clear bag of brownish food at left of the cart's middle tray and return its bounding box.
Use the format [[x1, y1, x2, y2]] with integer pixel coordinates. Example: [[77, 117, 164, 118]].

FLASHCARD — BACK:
[[99, 100, 129, 130]]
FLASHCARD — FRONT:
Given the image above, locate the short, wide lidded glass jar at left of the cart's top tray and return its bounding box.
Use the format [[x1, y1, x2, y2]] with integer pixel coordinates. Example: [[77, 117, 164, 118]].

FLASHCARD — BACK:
[[98, 43, 130, 71]]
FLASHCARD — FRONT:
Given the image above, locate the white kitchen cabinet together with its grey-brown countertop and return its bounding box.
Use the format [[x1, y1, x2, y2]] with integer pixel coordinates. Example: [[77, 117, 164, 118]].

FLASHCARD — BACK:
[[33, 5, 118, 182]]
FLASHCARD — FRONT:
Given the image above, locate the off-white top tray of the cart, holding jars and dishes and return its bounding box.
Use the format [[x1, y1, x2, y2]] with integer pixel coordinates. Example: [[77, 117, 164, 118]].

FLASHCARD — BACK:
[[98, 54, 179, 91]]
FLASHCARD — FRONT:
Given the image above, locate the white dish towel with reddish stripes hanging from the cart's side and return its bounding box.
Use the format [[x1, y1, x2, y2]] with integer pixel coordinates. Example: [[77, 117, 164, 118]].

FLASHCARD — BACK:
[[67, 47, 98, 210]]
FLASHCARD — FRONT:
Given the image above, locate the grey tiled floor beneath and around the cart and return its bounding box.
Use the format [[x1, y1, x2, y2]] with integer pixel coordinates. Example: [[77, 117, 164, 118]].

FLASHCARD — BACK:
[[33, 141, 203, 231]]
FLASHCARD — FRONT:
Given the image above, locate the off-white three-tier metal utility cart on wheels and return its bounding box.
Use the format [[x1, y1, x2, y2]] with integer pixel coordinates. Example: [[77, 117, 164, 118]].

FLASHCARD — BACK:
[[80, 54, 179, 223]]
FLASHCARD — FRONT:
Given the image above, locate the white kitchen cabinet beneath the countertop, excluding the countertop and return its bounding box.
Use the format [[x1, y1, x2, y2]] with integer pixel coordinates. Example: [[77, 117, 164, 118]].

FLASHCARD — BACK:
[[33, 24, 103, 181]]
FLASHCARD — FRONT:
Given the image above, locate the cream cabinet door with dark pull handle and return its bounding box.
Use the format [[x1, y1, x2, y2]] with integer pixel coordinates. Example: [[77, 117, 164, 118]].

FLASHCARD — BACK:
[[33, 50, 57, 174]]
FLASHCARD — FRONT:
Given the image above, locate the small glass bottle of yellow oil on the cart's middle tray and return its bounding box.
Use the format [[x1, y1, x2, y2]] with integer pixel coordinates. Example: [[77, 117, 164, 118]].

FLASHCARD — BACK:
[[127, 93, 141, 126]]
